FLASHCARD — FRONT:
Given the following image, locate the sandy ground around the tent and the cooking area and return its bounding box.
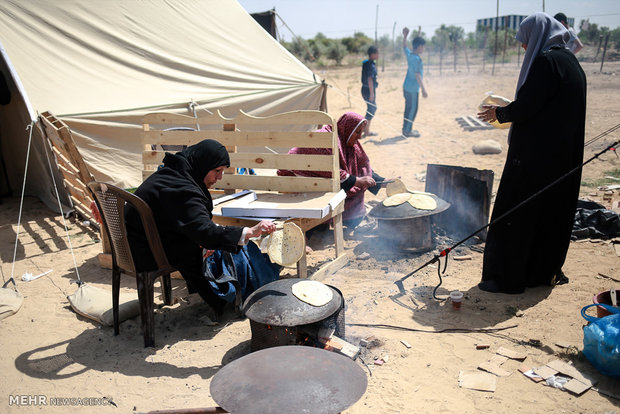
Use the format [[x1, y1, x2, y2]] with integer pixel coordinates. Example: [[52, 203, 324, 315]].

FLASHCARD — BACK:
[[0, 59, 620, 414]]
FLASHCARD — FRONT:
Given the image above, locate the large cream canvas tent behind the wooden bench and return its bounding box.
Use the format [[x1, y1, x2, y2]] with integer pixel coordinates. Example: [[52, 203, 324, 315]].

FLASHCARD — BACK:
[[0, 0, 325, 210]]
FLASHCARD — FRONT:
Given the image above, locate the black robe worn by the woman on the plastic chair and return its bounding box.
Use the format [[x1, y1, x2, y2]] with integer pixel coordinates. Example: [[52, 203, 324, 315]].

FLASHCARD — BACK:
[[125, 144, 243, 308]]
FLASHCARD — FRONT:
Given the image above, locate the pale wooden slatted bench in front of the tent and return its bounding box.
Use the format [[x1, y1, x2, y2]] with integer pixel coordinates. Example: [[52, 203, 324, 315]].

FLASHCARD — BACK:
[[142, 111, 347, 280]]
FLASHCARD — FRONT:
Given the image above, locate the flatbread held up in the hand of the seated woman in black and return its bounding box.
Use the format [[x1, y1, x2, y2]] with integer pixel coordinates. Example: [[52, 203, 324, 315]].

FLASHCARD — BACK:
[[261, 223, 306, 266]]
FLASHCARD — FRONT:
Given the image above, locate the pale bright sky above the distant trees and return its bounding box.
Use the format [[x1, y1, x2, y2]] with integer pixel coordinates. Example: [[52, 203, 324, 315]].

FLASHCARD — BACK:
[[238, 0, 620, 41]]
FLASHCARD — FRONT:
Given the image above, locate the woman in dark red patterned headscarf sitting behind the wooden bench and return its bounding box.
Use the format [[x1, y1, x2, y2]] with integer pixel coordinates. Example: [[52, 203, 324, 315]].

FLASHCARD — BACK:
[[278, 112, 384, 228]]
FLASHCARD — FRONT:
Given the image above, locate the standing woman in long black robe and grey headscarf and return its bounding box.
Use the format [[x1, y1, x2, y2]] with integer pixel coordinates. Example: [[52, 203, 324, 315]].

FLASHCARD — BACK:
[[478, 13, 586, 293]]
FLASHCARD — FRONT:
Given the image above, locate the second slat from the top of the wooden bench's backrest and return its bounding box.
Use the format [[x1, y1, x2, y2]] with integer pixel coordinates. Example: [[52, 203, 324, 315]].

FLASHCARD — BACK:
[[140, 130, 335, 148]]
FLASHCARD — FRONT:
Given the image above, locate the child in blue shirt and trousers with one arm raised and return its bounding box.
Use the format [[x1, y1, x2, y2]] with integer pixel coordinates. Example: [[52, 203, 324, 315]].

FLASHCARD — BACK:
[[403, 27, 428, 138]]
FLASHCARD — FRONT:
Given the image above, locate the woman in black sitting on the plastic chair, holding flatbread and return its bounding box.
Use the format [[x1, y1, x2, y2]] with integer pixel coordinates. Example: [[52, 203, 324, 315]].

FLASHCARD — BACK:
[[125, 139, 281, 313]]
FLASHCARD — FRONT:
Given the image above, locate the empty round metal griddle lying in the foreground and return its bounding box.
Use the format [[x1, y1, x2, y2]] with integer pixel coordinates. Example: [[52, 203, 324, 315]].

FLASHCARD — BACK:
[[211, 345, 368, 414]]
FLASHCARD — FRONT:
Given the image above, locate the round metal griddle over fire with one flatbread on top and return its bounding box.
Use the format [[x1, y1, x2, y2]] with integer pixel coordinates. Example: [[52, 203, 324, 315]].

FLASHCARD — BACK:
[[243, 278, 342, 326]]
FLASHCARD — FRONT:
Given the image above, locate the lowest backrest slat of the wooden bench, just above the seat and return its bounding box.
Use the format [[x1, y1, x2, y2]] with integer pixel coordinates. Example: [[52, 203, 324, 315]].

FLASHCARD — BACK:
[[216, 172, 334, 193]]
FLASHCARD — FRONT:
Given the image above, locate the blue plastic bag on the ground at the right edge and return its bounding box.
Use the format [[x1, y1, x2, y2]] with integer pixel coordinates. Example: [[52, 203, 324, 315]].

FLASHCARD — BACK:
[[581, 303, 620, 377]]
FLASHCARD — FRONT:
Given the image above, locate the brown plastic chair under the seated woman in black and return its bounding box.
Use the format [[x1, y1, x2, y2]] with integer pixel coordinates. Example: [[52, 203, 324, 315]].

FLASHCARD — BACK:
[[88, 181, 176, 347]]
